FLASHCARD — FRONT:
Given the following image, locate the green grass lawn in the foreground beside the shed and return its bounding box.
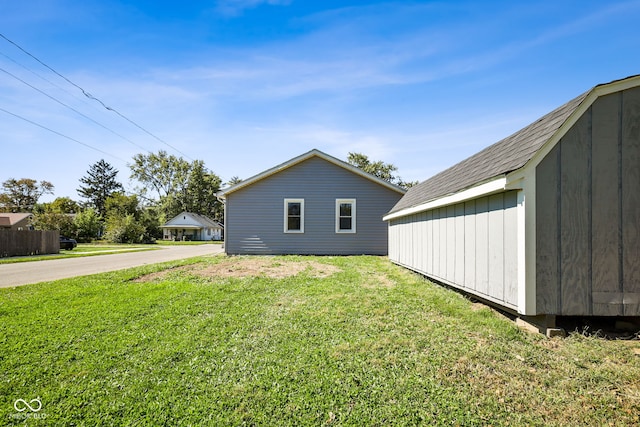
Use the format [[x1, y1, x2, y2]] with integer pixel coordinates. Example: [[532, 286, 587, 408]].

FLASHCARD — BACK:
[[0, 256, 640, 426]]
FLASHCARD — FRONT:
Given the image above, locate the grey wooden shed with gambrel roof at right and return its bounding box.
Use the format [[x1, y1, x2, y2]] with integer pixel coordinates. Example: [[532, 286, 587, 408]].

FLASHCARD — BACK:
[[385, 76, 640, 327]]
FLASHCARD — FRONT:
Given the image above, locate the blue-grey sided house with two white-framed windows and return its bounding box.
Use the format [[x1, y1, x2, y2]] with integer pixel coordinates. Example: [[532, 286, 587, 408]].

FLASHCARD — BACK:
[[218, 150, 405, 255]]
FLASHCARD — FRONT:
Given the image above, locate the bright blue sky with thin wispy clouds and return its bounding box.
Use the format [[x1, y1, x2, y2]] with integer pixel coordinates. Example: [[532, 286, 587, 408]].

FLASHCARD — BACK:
[[0, 0, 640, 201]]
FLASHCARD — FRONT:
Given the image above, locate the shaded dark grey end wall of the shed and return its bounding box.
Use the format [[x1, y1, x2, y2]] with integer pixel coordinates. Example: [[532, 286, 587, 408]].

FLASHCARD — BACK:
[[536, 88, 640, 316]]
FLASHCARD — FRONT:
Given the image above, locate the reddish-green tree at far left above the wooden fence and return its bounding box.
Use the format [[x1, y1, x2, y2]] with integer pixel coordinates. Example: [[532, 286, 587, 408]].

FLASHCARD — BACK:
[[0, 178, 55, 212]]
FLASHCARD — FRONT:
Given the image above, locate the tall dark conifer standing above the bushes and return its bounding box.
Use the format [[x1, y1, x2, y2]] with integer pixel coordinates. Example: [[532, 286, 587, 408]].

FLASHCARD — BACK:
[[77, 159, 124, 216]]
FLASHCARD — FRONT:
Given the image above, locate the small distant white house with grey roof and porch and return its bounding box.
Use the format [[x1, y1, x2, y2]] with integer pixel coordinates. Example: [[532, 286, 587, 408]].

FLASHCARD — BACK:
[[160, 212, 223, 240]]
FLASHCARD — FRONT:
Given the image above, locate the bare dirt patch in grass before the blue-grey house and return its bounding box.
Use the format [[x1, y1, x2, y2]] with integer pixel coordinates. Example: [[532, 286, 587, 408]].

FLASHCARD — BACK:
[[136, 257, 341, 282]]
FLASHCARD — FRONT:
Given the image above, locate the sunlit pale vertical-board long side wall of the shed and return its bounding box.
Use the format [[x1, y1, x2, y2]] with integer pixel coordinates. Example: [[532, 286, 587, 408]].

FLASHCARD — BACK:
[[389, 191, 518, 309]]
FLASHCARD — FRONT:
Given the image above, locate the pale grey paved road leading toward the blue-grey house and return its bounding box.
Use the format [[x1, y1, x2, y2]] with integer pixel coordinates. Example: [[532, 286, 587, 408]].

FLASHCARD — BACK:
[[0, 244, 223, 288]]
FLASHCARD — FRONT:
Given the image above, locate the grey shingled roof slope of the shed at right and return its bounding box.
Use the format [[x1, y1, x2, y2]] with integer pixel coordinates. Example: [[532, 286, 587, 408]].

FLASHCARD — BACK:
[[389, 90, 591, 214]]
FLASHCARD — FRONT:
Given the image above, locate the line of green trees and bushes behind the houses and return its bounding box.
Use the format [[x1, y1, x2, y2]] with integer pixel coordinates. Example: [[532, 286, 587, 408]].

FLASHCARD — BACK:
[[0, 150, 416, 243]]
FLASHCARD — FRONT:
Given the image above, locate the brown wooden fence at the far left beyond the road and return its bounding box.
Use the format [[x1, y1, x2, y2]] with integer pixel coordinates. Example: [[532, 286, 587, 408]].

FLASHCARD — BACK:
[[0, 230, 60, 258]]
